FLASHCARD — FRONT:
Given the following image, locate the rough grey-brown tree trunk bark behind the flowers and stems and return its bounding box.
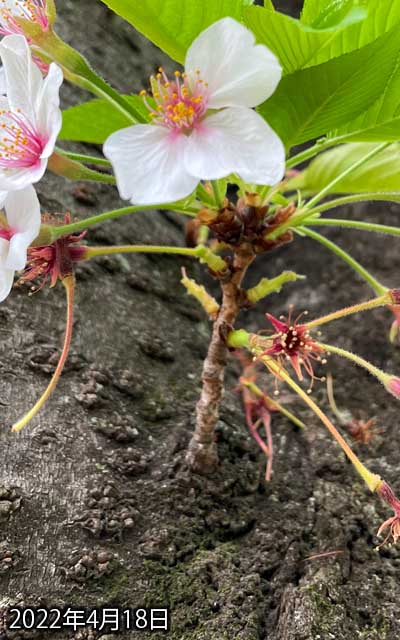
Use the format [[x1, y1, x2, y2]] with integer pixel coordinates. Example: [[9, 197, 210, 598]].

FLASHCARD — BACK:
[[0, 0, 400, 640]]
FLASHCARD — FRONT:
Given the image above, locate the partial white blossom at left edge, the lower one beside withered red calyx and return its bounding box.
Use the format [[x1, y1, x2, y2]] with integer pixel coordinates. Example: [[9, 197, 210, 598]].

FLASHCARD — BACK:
[[0, 186, 41, 302]]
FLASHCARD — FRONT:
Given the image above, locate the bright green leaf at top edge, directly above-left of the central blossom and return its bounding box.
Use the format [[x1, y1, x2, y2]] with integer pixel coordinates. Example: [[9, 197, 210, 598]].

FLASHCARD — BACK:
[[101, 0, 253, 62]]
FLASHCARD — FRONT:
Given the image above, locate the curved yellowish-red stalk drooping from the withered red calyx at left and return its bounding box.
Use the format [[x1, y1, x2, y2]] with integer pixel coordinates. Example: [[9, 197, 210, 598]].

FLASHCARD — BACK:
[[12, 274, 75, 433]]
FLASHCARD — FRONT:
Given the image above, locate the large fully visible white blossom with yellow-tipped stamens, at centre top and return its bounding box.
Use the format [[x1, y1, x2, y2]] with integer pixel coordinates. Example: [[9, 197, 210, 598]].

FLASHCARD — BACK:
[[104, 18, 285, 204]]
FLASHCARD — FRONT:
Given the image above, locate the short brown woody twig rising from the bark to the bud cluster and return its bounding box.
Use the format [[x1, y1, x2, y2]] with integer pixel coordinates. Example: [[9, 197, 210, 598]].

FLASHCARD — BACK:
[[186, 248, 254, 475]]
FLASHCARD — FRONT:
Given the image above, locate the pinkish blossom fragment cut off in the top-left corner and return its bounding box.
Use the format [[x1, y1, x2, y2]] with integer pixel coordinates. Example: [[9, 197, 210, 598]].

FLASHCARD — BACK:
[[0, 0, 50, 35]]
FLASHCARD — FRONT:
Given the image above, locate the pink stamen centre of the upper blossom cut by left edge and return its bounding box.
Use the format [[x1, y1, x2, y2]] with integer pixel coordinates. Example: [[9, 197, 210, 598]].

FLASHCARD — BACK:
[[0, 111, 47, 169]]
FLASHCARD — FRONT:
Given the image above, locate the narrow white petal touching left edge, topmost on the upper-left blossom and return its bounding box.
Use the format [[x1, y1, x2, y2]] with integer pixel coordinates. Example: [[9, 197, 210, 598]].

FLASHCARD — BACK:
[[0, 35, 43, 123]]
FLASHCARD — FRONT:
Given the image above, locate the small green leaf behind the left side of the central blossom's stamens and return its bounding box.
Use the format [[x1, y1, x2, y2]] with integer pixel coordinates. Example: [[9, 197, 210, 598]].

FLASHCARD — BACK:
[[59, 96, 150, 144]]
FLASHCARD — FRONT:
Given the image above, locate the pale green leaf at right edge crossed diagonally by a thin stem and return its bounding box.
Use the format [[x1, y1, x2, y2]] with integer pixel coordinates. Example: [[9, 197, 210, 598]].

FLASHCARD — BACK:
[[288, 142, 400, 193]]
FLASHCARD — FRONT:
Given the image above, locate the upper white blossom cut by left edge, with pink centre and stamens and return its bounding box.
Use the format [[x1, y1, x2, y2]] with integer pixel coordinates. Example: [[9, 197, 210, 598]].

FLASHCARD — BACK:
[[0, 35, 63, 191]]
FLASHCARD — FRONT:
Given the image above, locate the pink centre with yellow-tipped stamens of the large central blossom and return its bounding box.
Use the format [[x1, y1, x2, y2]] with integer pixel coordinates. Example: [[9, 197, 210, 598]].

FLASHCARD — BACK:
[[140, 68, 209, 133]]
